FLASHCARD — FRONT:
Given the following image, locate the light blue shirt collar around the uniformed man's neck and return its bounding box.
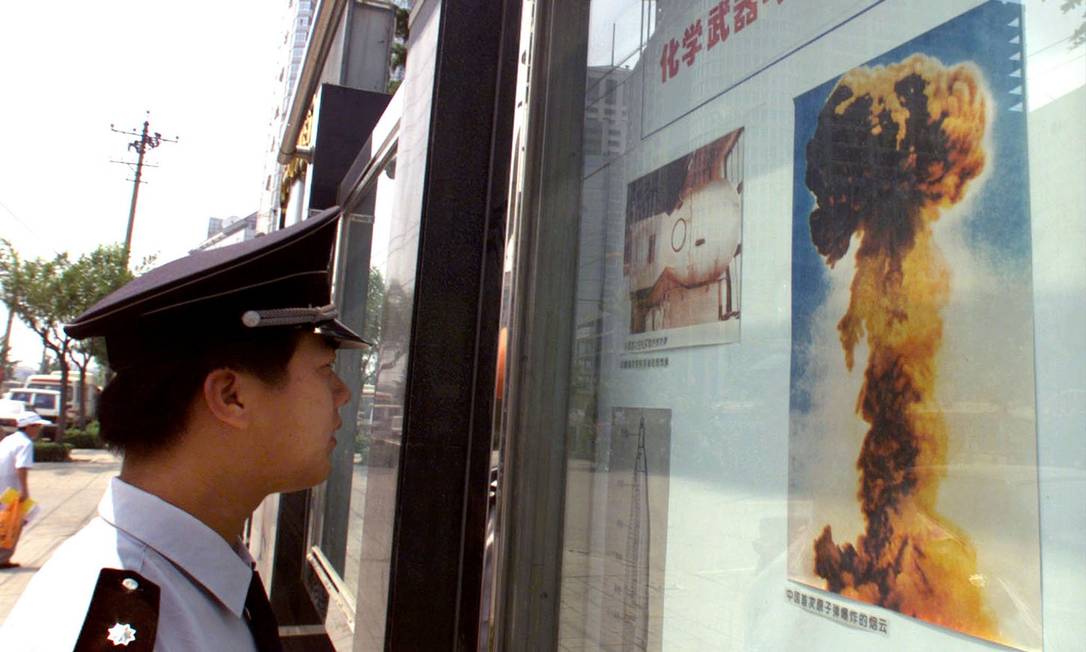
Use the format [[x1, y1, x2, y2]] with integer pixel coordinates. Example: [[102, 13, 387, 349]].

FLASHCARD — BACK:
[[98, 478, 253, 617]]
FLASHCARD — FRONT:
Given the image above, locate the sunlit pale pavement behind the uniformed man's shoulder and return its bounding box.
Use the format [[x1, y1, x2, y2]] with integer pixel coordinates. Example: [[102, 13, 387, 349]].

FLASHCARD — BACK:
[[0, 449, 121, 623]]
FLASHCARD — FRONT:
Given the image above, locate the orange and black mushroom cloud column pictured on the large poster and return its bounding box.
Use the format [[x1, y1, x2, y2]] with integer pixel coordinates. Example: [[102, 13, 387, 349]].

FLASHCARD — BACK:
[[806, 54, 998, 640]]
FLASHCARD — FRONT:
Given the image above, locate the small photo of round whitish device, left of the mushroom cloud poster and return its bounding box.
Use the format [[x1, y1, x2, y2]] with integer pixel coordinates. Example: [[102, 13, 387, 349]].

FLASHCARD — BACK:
[[622, 128, 743, 347]]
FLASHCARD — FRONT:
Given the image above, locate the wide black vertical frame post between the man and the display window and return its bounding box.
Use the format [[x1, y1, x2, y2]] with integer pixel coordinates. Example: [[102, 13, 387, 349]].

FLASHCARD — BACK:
[[375, 0, 520, 650]]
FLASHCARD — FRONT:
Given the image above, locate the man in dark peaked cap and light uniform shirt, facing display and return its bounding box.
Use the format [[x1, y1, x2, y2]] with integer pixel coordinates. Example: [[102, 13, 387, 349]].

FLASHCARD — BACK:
[[0, 210, 366, 652]]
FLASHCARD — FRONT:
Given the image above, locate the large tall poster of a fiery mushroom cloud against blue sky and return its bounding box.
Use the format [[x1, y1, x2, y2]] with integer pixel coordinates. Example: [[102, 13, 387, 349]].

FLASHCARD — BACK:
[[788, 1, 1041, 650]]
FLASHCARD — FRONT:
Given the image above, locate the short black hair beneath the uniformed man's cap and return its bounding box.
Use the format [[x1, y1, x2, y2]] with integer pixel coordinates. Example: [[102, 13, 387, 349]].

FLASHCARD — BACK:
[[98, 328, 303, 455]]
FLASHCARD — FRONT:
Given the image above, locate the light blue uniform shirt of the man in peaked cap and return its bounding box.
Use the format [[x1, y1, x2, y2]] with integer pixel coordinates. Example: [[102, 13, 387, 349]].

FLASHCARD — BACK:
[[0, 478, 256, 652]]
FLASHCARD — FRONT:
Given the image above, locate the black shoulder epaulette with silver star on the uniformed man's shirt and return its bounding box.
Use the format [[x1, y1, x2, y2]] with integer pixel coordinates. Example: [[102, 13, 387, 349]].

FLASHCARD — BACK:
[[74, 568, 159, 652]]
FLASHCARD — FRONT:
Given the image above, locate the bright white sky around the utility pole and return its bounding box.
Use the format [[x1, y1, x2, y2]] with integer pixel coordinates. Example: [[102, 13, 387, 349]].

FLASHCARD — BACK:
[[0, 0, 287, 364]]
